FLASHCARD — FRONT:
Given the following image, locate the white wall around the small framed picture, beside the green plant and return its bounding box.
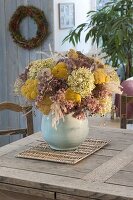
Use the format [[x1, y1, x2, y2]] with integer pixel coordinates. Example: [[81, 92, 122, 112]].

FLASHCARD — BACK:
[[54, 0, 95, 53]]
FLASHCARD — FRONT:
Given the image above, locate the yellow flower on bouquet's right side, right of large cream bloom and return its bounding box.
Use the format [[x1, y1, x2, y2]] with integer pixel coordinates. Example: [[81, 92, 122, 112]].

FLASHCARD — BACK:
[[94, 68, 110, 84]]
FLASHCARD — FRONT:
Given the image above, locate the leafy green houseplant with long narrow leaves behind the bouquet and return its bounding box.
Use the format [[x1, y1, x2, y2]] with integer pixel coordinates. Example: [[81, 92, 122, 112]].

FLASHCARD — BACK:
[[63, 0, 133, 78]]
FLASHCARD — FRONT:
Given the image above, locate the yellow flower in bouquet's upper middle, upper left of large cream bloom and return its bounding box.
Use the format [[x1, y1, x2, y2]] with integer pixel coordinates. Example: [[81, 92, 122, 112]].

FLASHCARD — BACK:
[[52, 62, 68, 79]]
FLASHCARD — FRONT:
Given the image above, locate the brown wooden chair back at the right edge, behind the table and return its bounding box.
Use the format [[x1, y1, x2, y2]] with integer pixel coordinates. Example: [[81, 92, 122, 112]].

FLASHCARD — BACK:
[[120, 94, 133, 129]]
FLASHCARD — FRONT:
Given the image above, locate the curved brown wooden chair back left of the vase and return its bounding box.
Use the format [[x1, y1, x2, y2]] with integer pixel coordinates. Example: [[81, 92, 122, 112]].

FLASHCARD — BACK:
[[0, 102, 34, 137]]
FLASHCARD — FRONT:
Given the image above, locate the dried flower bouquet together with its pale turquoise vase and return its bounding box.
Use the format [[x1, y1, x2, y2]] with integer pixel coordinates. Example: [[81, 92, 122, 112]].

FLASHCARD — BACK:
[[14, 49, 120, 150]]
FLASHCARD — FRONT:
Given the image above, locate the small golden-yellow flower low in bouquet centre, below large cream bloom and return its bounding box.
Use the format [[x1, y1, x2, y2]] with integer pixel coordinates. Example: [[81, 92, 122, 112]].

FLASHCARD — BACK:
[[65, 88, 81, 103]]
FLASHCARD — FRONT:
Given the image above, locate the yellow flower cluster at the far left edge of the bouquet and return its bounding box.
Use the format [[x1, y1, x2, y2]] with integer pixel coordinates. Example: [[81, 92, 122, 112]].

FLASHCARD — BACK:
[[21, 79, 38, 100]]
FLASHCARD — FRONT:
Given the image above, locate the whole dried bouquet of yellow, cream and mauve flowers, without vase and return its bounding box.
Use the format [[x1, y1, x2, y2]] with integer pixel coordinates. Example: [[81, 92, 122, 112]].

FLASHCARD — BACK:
[[14, 49, 121, 127]]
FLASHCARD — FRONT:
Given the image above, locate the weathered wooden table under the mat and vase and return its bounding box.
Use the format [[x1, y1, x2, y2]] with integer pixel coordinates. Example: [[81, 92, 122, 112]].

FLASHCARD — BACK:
[[0, 127, 133, 200]]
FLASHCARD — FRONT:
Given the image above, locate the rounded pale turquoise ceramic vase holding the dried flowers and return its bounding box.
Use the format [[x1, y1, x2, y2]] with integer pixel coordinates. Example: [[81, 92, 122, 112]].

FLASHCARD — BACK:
[[41, 114, 89, 150]]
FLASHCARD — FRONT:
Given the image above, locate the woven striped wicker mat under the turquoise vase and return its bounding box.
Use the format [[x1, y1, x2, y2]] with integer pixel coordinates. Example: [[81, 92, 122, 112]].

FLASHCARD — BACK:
[[16, 139, 109, 164]]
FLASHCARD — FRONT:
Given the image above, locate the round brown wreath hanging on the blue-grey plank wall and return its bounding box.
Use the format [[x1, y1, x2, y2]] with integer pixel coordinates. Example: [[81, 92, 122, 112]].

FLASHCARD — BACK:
[[9, 6, 48, 49]]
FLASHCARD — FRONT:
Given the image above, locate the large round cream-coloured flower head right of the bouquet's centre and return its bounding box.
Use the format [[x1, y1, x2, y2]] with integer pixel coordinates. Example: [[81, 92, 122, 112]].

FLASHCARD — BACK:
[[68, 67, 95, 98]]
